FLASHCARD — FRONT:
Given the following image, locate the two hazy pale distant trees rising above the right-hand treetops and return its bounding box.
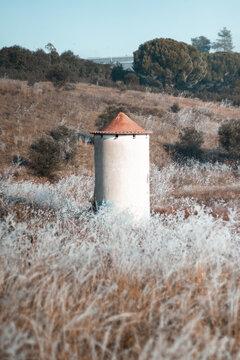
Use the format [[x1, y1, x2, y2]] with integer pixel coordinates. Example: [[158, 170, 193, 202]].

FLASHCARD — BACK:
[[191, 27, 234, 53]]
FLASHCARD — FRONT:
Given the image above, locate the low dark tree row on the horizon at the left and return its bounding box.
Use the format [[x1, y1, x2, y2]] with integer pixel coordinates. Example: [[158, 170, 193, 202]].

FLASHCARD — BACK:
[[0, 43, 112, 86]]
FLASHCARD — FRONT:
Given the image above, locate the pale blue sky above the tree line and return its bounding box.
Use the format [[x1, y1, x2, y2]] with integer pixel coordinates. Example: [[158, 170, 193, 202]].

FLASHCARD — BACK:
[[0, 0, 240, 58]]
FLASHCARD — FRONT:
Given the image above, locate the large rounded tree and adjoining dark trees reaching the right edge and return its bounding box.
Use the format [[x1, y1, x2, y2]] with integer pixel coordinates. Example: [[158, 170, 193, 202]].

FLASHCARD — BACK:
[[134, 38, 240, 93]]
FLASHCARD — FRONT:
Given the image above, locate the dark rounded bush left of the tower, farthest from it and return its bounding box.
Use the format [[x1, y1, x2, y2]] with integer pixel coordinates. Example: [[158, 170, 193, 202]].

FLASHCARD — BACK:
[[29, 134, 61, 177]]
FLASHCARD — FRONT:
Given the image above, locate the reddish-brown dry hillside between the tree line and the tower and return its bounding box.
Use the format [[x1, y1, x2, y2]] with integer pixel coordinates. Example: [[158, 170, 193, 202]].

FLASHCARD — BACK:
[[0, 80, 240, 175]]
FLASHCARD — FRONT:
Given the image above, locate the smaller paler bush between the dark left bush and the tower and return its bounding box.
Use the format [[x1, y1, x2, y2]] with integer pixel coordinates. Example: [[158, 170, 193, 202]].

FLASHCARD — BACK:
[[49, 125, 77, 162]]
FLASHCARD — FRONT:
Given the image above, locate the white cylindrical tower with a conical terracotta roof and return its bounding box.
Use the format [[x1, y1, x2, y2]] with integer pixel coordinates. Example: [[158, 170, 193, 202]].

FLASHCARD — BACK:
[[92, 113, 151, 219]]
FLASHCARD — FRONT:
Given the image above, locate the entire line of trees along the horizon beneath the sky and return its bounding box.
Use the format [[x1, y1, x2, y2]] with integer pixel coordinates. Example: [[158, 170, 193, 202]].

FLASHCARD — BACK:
[[0, 28, 240, 105]]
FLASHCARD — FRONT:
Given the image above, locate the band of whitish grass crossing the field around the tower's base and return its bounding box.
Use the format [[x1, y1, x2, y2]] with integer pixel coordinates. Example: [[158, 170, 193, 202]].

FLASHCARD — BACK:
[[0, 169, 240, 275]]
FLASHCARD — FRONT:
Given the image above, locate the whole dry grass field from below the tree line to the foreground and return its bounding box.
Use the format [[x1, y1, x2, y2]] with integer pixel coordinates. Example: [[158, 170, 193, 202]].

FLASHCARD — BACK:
[[0, 80, 240, 360]]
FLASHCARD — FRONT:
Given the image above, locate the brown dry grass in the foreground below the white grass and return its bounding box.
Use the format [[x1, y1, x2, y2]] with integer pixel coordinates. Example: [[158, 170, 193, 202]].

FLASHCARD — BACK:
[[0, 259, 240, 360]]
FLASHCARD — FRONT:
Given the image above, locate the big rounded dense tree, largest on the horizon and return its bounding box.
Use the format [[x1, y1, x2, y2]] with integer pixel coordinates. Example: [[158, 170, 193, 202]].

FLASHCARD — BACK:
[[134, 39, 207, 89]]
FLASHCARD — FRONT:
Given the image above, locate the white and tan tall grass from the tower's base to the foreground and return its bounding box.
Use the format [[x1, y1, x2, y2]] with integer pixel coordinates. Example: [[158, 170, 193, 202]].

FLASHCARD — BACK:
[[0, 163, 240, 360]]
